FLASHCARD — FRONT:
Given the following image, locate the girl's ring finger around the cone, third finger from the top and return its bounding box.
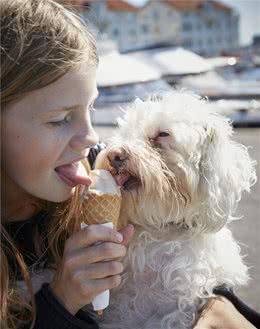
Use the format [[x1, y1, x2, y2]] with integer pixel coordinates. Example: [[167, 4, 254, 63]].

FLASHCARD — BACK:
[[78, 261, 124, 280]]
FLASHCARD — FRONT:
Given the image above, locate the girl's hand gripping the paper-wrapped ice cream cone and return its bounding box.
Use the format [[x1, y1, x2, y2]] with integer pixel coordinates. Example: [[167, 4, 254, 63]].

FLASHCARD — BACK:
[[50, 225, 133, 315]]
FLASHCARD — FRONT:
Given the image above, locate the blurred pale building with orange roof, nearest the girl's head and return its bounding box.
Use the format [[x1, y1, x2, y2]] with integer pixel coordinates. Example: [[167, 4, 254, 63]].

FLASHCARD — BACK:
[[87, 0, 181, 52]]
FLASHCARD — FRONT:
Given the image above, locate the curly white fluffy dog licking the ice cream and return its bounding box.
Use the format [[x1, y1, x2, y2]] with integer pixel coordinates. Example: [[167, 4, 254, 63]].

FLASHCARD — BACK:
[[96, 92, 256, 329]]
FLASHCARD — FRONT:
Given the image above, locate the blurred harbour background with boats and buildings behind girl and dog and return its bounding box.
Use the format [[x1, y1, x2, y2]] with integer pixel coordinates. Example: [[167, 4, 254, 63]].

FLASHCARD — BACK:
[[59, 0, 260, 311]]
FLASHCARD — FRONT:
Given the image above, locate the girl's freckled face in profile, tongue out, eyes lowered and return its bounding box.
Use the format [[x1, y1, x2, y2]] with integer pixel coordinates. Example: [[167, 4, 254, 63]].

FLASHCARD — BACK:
[[2, 64, 98, 202]]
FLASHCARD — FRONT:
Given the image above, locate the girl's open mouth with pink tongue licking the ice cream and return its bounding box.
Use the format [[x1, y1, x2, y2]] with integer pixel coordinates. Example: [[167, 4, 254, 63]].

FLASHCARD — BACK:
[[55, 162, 92, 187]]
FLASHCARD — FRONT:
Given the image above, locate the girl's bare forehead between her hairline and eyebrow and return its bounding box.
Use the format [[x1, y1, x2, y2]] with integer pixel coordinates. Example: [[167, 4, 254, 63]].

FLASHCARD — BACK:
[[4, 64, 97, 114]]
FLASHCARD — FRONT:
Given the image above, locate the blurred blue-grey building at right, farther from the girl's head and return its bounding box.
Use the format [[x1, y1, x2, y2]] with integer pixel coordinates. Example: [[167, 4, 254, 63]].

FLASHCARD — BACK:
[[171, 0, 239, 56]]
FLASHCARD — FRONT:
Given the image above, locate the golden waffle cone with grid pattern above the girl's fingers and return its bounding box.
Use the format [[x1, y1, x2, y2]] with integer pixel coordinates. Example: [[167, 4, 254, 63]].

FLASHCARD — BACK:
[[83, 192, 121, 228]]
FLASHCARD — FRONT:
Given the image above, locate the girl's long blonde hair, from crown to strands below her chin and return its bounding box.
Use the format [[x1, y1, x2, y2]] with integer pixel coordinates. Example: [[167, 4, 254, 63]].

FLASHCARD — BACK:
[[0, 0, 98, 328]]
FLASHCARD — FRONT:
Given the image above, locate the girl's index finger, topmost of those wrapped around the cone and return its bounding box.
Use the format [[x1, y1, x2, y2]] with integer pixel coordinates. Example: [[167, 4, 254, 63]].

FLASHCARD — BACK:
[[65, 225, 123, 250]]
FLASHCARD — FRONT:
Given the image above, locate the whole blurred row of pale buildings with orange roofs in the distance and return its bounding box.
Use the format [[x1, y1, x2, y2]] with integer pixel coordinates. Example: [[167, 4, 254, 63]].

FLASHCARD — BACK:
[[82, 0, 239, 56]]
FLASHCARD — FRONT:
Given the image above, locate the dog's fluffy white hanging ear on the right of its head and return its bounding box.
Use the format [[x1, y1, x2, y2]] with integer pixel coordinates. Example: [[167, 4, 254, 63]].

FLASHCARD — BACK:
[[199, 117, 256, 232]]
